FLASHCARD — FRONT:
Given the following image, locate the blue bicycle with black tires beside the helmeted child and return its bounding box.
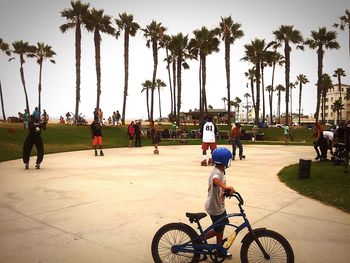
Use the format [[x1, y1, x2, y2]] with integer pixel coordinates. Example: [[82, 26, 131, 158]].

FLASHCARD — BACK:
[[151, 192, 294, 263]]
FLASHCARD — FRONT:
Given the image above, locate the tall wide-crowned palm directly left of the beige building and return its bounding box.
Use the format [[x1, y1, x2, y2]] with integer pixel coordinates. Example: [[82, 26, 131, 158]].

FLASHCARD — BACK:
[[305, 27, 339, 122]]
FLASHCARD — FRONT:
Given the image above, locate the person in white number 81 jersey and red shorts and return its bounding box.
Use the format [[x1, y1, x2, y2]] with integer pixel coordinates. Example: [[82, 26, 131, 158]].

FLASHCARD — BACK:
[[199, 117, 218, 166]]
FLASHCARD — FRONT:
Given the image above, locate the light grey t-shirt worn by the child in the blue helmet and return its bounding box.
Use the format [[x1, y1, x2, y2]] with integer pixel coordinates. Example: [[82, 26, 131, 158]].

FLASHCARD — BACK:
[[205, 167, 226, 216]]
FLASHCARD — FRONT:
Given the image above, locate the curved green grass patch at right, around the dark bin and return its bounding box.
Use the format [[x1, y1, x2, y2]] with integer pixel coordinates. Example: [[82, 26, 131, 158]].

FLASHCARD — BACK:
[[278, 162, 350, 213]]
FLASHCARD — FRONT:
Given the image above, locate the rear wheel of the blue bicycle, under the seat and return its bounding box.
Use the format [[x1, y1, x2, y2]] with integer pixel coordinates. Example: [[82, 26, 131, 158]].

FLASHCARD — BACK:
[[152, 223, 200, 263]]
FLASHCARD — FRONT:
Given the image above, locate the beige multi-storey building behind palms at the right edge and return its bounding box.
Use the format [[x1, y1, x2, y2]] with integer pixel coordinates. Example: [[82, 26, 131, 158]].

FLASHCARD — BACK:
[[319, 84, 350, 124]]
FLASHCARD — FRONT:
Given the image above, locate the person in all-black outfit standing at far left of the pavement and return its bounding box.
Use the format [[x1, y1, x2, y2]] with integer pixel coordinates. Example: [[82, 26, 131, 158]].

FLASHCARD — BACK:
[[23, 115, 46, 170]]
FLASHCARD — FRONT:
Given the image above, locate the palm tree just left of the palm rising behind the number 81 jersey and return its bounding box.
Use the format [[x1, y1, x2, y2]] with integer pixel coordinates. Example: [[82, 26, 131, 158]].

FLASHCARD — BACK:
[[173, 33, 193, 123]]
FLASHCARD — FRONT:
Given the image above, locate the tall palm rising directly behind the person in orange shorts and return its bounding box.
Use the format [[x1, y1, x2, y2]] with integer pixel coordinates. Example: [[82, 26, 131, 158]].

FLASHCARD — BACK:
[[86, 8, 115, 111]]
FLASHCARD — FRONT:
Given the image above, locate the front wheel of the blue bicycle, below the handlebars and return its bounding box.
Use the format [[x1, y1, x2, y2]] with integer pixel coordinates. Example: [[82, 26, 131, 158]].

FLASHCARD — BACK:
[[241, 229, 294, 263]]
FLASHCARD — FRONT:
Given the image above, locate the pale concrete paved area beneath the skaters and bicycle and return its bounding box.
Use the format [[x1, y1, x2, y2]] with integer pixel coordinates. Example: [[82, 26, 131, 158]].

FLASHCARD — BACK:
[[0, 145, 350, 263]]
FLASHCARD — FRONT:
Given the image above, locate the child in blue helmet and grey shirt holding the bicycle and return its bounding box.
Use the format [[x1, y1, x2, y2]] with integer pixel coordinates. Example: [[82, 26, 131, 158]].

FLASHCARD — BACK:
[[205, 147, 236, 256]]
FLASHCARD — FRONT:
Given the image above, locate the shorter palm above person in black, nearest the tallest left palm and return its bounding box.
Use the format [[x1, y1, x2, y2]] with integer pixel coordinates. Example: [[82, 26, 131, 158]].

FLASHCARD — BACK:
[[34, 42, 56, 112]]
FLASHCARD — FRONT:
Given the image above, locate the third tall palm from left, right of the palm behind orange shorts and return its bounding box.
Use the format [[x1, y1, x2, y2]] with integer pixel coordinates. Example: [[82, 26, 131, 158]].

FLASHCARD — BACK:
[[115, 12, 140, 125]]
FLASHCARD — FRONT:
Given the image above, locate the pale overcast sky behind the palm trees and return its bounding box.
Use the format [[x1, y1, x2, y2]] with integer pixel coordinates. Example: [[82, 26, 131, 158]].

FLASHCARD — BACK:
[[0, 0, 350, 119]]
